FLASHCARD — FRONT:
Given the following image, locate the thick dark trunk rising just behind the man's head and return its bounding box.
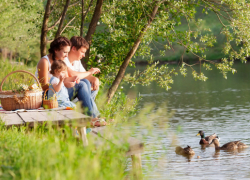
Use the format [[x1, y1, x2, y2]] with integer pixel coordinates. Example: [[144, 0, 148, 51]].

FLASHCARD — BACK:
[[81, 0, 103, 69]]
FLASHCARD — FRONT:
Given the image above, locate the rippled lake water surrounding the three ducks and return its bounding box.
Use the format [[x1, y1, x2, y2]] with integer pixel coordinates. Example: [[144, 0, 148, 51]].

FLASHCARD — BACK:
[[124, 63, 250, 179]]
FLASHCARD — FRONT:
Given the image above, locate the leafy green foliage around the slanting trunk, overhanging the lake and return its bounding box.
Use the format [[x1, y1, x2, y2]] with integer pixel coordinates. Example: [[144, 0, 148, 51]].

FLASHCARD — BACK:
[[90, 0, 250, 90]]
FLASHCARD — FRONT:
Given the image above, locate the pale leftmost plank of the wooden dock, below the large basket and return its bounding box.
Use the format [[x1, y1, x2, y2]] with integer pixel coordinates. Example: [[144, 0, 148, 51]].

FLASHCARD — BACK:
[[0, 113, 24, 126]]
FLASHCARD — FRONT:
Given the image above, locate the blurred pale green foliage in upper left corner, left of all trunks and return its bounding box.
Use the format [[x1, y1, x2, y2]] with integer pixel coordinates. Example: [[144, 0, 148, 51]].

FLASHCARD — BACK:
[[0, 0, 43, 62]]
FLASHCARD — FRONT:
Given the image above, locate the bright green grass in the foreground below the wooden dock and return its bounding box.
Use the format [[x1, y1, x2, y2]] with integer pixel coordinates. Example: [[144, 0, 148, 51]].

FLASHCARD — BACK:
[[0, 126, 129, 180]]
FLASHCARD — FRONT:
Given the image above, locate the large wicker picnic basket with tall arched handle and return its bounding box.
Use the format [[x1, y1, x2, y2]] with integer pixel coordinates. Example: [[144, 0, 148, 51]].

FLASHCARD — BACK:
[[0, 70, 42, 111]]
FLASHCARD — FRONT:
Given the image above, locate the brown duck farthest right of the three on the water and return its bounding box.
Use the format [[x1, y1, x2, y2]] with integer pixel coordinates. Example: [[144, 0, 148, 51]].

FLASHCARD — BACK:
[[211, 138, 248, 150]]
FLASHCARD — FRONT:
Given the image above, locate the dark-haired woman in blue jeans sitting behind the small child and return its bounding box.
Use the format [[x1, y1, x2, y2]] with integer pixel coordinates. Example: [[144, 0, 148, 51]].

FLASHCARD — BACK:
[[36, 37, 106, 126]]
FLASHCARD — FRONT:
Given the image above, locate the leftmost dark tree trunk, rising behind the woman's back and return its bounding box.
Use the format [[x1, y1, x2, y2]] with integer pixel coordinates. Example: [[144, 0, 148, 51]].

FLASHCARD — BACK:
[[40, 0, 51, 57]]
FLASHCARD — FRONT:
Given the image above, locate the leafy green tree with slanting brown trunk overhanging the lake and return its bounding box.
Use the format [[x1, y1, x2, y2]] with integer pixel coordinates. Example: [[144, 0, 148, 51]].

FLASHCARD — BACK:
[[37, 0, 250, 102]]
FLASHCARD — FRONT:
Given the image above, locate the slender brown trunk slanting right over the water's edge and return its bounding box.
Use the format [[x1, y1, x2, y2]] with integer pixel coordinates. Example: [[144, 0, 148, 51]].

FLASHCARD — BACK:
[[107, 2, 160, 103]]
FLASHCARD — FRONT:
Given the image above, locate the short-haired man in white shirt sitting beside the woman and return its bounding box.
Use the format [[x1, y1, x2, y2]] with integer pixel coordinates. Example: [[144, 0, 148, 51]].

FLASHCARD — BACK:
[[65, 36, 100, 99]]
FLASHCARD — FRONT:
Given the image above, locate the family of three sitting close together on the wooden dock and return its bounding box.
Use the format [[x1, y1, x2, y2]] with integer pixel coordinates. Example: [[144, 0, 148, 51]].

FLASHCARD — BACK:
[[36, 36, 106, 126]]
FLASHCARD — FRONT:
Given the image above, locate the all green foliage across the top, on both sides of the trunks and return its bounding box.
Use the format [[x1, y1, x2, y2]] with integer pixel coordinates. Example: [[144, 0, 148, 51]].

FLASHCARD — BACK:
[[0, 0, 250, 95]]
